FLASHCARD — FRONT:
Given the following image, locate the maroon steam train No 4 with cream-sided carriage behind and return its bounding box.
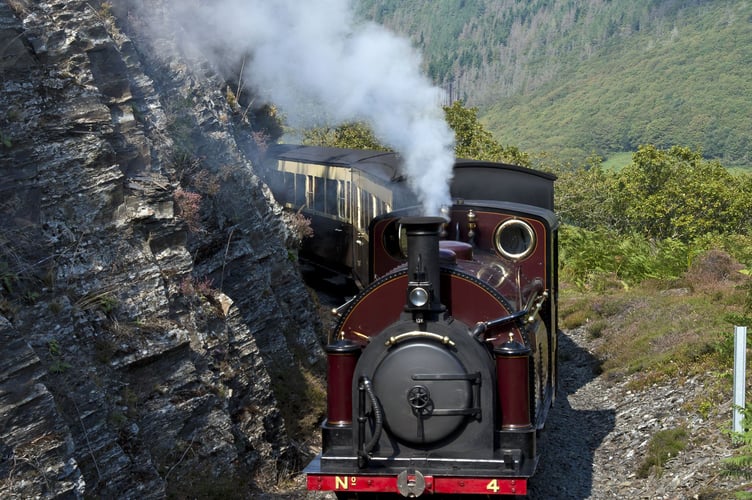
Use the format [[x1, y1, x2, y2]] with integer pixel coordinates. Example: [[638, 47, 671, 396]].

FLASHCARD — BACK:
[[262, 146, 558, 498]]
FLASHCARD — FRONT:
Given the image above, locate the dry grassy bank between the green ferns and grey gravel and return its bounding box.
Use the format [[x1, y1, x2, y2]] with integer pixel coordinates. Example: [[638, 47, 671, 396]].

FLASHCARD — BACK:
[[560, 256, 747, 392]]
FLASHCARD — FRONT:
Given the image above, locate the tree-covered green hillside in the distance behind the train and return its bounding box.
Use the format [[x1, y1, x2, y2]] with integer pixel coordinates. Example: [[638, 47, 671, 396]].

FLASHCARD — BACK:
[[359, 0, 752, 166]]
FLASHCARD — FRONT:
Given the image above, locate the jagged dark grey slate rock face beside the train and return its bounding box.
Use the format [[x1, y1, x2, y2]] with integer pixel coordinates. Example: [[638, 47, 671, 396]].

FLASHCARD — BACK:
[[0, 0, 322, 498]]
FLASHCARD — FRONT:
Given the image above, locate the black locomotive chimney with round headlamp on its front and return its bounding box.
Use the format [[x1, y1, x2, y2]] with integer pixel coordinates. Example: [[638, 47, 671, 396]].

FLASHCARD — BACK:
[[400, 217, 446, 323]]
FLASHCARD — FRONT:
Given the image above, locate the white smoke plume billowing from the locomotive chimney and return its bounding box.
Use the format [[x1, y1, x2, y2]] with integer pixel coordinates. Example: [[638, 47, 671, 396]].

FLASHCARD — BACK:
[[169, 0, 454, 215]]
